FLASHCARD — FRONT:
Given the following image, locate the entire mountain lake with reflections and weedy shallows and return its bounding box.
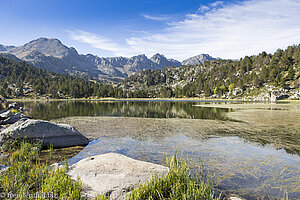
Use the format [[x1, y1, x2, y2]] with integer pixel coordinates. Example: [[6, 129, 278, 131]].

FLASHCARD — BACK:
[[20, 101, 300, 199]]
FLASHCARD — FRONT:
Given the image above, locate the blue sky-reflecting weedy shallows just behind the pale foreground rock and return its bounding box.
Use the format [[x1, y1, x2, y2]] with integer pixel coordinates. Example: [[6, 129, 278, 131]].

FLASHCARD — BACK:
[[69, 135, 300, 199]]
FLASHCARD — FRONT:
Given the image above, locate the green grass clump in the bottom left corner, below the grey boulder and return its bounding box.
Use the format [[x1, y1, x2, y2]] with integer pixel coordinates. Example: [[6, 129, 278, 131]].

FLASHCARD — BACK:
[[0, 142, 82, 199]]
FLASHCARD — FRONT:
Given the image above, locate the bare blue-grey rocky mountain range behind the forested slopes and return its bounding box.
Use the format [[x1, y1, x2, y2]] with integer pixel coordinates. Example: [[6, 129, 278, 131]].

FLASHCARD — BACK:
[[0, 38, 216, 81]]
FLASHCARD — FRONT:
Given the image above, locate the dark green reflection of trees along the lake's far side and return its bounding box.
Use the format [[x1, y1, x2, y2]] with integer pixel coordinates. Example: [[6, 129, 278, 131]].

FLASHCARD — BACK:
[[23, 101, 226, 120]]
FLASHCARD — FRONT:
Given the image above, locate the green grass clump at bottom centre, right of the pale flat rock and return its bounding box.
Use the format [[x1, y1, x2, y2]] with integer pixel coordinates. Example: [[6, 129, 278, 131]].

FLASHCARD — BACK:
[[129, 156, 217, 200]]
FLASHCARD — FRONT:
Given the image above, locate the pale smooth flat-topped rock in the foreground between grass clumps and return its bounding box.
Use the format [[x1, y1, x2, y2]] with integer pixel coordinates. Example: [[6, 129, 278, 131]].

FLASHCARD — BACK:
[[68, 153, 169, 199]]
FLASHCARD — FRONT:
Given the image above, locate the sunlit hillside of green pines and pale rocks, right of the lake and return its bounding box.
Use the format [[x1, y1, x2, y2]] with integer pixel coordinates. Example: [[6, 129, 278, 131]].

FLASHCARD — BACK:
[[123, 45, 300, 100]]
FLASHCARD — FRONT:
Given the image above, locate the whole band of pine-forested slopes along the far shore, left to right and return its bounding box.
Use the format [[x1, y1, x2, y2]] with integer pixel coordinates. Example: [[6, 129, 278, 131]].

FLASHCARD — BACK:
[[0, 45, 300, 101]]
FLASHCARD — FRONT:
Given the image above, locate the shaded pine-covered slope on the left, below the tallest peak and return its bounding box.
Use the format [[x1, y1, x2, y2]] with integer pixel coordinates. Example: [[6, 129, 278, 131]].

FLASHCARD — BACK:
[[0, 56, 123, 98]]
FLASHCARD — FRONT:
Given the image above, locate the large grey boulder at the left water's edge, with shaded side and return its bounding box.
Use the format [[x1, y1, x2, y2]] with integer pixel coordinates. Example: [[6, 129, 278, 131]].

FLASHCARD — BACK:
[[0, 119, 89, 148]]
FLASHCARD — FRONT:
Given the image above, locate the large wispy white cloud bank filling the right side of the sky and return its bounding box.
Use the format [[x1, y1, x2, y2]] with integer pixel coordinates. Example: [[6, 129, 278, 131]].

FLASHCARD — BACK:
[[67, 0, 300, 60]]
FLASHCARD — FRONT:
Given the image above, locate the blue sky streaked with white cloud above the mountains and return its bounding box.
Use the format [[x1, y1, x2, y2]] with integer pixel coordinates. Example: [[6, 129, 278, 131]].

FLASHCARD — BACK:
[[0, 0, 300, 60]]
